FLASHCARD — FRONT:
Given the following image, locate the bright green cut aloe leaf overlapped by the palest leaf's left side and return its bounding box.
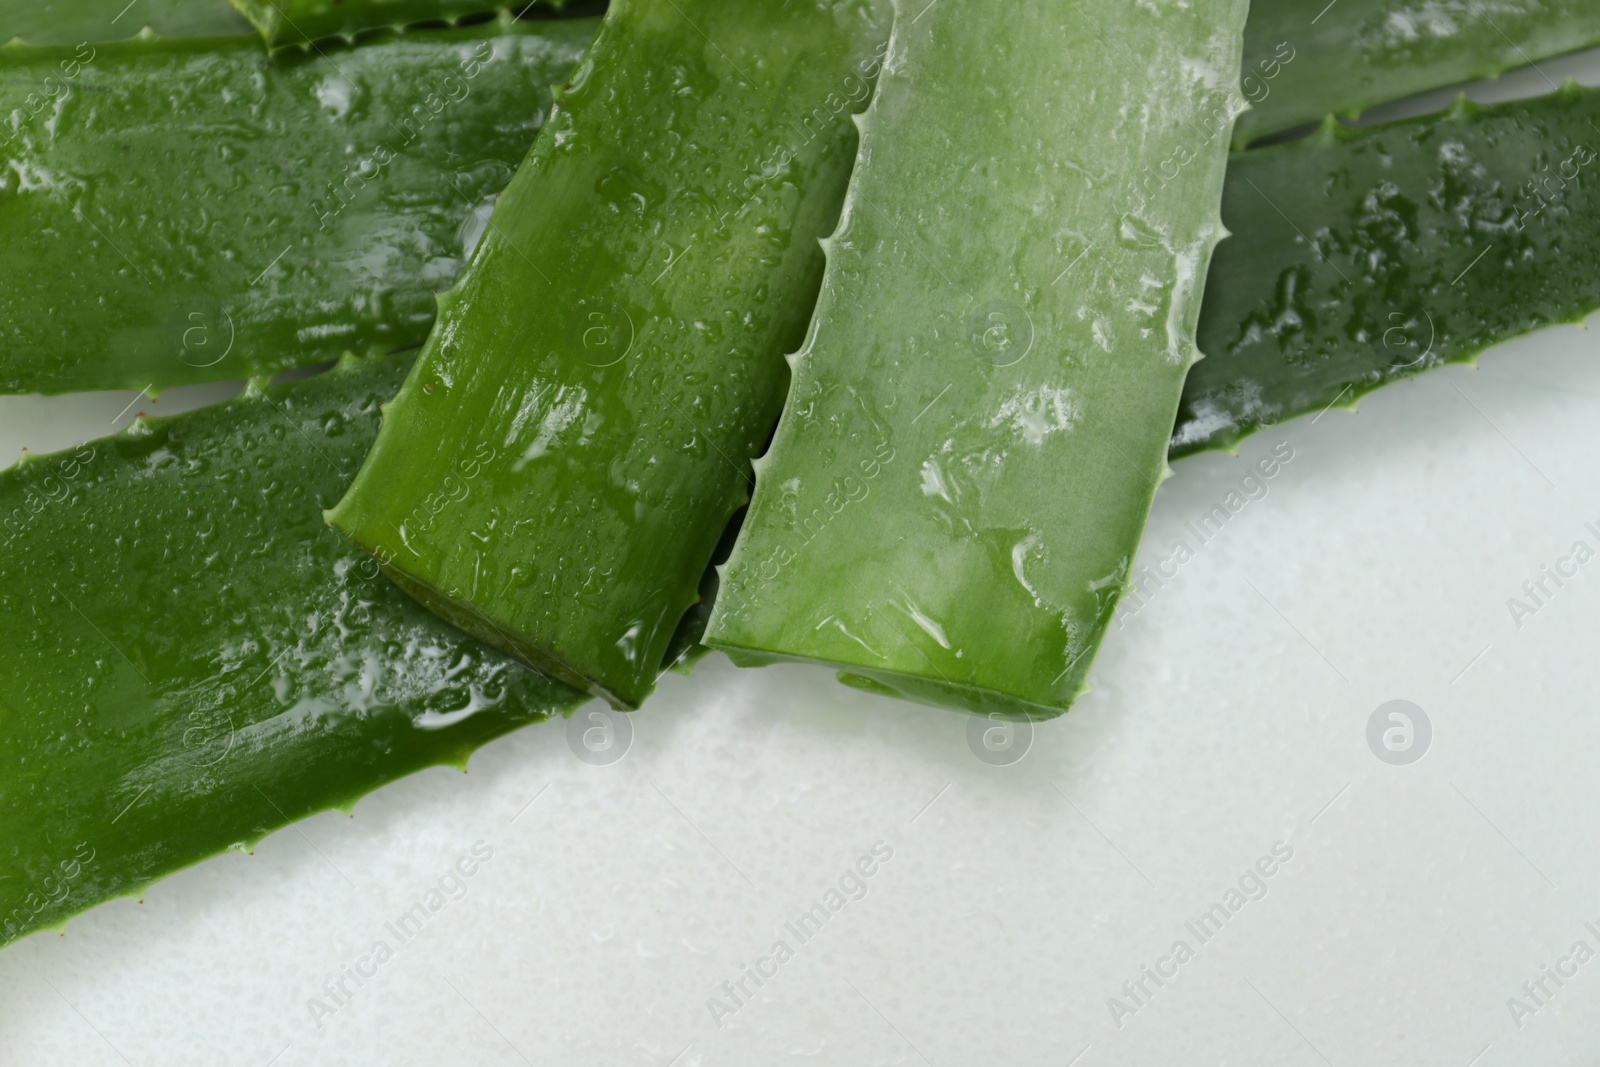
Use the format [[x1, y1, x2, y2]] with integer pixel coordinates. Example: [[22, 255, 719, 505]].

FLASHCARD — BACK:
[[330, 0, 890, 707]]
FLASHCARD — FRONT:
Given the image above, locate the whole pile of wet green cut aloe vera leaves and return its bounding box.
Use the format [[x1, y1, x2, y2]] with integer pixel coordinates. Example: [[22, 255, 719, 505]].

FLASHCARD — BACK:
[[0, 0, 1600, 944]]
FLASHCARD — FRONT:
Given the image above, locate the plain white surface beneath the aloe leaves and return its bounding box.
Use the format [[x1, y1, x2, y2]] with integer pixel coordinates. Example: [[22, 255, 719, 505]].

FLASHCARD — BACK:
[[0, 47, 1600, 1067]]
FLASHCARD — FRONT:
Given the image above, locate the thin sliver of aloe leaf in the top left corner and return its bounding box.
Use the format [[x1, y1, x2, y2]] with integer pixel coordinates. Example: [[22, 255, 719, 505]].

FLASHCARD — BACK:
[[0, 0, 251, 45]]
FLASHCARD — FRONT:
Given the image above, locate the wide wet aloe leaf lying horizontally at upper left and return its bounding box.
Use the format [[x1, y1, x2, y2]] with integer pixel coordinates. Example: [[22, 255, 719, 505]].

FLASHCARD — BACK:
[[0, 19, 598, 394]]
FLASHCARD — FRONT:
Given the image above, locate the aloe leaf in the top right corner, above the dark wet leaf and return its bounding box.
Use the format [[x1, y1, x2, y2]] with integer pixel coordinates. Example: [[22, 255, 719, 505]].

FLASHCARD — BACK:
[[1234, 0, 1600, 147]]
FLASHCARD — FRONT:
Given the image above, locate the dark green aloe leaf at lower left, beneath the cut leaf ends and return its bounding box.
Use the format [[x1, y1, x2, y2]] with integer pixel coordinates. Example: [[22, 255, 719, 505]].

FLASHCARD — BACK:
[[0, 355, 587, 944]]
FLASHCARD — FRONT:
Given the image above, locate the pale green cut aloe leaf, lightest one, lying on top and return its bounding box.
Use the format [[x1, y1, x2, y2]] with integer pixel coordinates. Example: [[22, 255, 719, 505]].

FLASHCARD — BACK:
[[707, 0, 1246, 718]]
